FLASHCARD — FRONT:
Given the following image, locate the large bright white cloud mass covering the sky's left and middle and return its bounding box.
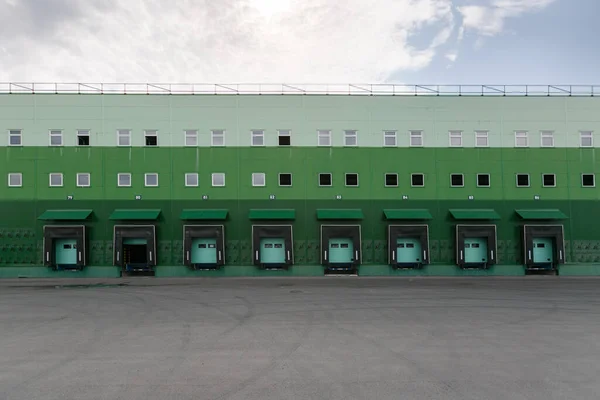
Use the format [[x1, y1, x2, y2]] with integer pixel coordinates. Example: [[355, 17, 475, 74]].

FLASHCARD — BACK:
[[0, 0, 454, 83]]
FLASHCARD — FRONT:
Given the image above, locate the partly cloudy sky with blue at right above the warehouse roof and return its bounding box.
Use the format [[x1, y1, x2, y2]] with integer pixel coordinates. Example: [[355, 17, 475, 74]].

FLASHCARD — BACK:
[[0, 0, 600, 85]]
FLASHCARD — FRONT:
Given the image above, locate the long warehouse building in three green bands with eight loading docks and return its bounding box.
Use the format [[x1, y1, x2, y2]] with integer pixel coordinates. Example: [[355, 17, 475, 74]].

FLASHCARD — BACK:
[[0, 84, 600, 277]]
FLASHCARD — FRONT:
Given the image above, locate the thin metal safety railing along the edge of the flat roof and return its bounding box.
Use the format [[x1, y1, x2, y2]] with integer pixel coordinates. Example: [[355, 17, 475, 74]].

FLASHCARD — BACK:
[[0, 82, 600, 97]]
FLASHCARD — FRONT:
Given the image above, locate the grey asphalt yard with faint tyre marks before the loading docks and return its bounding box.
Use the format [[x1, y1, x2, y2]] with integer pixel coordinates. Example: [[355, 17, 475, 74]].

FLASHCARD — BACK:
[[0, 277, 600, 400]]
